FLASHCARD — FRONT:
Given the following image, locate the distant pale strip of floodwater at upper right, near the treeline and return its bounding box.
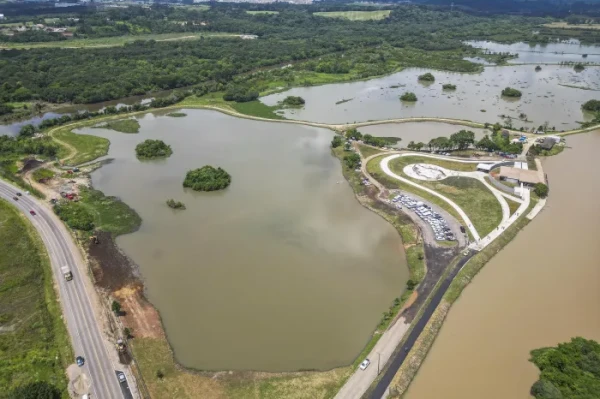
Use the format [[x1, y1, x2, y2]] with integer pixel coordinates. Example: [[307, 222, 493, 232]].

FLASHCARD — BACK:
[[465, 39, 600, 64]]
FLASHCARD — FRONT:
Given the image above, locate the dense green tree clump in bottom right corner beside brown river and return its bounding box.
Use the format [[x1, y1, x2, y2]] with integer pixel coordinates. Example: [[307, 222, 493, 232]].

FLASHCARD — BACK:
[[530, 337, 600, 399]]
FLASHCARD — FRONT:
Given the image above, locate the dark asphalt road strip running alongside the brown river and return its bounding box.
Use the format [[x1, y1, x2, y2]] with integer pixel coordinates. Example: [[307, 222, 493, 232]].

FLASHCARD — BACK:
[[367, 251, 477, 399]]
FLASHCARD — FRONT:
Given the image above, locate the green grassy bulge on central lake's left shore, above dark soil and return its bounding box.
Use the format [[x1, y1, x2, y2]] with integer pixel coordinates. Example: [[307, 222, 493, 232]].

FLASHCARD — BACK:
[[79, 186, 142, 237]]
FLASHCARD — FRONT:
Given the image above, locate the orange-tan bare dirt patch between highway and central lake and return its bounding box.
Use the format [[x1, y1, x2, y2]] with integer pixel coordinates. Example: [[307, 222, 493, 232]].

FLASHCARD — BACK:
[[113, 283, 164, 338]]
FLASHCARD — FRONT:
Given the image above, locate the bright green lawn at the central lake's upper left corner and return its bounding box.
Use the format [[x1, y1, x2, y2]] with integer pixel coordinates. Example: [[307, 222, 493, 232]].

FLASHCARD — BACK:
[[52, 127, 110, 165]]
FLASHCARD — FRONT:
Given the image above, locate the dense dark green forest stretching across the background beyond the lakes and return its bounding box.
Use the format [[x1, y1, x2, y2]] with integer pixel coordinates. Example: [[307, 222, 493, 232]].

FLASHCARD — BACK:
[[0, 4, 543, 103]]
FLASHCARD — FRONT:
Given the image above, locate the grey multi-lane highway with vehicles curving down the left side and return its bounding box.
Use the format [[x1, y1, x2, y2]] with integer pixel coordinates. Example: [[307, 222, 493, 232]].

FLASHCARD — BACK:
[[0, 180, 123, 399]]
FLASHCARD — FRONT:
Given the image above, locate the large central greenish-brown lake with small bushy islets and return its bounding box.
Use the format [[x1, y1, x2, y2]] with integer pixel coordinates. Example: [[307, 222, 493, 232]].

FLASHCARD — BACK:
[[77, 110, 408, 371]]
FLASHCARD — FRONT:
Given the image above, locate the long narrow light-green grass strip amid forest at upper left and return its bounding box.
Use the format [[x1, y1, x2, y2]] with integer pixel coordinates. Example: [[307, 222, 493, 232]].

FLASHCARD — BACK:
[[0, 32, 238, 49]]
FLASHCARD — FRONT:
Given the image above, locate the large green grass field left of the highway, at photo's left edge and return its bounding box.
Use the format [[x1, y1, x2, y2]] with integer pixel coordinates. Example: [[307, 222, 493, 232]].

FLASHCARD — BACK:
[[0, 200, 73, 398]]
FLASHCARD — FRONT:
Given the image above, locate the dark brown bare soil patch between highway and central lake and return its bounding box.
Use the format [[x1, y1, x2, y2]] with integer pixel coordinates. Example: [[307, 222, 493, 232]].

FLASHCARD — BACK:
[[88, 232, 139, 292]]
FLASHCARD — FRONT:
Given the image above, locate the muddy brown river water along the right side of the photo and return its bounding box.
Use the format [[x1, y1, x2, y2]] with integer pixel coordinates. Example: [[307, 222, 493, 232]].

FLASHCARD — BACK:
[[406, 131, 600, 399]]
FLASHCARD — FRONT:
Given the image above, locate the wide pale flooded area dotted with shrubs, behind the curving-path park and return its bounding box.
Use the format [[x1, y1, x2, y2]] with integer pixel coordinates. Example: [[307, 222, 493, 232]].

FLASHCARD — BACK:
[[262, 65, 600, 130]]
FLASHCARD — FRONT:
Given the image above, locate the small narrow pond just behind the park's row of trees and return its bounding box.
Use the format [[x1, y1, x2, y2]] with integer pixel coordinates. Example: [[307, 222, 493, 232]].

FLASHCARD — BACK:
[[360, 122, 491, 148]]
